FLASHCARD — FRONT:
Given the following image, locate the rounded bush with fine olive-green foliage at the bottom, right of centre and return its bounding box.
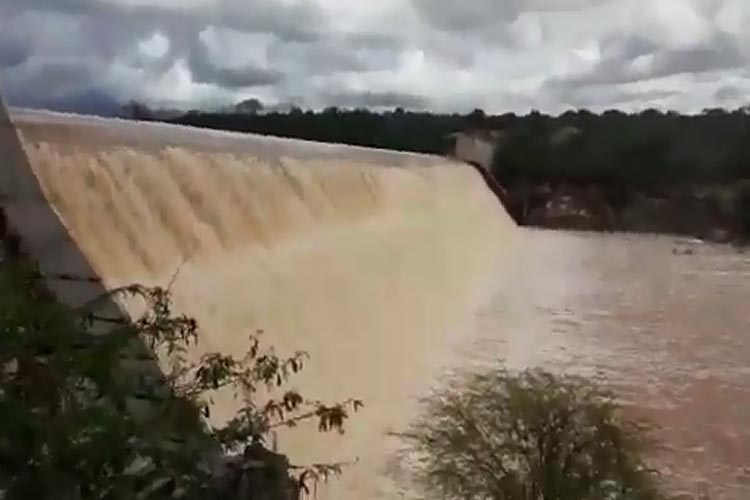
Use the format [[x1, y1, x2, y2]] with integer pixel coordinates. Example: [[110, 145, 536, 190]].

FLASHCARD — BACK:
[[405, 368, 660, 500]]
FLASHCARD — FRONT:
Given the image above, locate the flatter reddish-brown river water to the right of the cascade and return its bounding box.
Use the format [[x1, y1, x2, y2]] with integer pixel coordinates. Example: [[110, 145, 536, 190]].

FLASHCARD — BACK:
[[470, 230, 750, 500]]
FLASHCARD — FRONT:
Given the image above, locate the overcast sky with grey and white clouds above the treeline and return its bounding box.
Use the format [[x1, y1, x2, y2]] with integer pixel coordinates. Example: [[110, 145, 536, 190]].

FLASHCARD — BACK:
[[0, 0, 750, 112]]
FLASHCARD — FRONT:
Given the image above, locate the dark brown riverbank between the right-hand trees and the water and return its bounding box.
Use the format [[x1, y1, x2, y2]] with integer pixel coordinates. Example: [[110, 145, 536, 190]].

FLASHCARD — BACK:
[[504, 181, 750, 244]]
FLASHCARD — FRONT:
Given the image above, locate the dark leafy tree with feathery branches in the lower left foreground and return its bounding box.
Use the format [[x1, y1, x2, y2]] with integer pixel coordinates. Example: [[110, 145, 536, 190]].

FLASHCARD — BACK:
[[0, 251, 361, 500]]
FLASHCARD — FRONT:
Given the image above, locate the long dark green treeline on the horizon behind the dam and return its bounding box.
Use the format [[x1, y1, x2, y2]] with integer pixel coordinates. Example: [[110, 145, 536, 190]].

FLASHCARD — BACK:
[[160, 107, 750, 186]]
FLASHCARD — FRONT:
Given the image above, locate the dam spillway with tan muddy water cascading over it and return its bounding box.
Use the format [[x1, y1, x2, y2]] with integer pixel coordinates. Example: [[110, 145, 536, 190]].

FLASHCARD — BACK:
[[0, 103, 514, 498]]
